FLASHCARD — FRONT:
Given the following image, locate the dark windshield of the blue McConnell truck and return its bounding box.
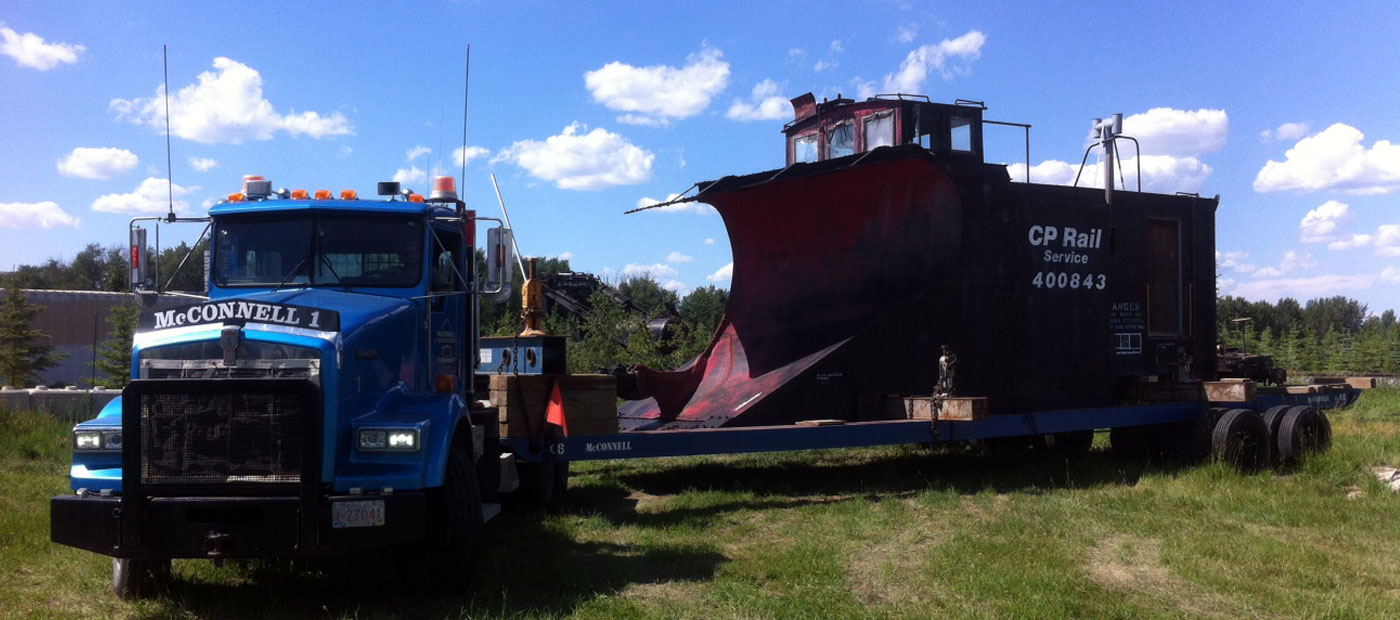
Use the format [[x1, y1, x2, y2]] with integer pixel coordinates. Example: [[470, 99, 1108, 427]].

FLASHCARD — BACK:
[[213, 214, 423, 288]]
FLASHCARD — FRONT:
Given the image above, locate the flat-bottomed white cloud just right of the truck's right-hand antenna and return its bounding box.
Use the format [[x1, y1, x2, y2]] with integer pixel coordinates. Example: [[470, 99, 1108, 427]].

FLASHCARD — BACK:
[[491, 122, 657, 190]]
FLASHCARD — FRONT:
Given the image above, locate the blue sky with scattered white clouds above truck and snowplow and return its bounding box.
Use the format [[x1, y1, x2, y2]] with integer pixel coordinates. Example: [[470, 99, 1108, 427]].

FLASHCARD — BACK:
[[0, 0, 1400, 312]]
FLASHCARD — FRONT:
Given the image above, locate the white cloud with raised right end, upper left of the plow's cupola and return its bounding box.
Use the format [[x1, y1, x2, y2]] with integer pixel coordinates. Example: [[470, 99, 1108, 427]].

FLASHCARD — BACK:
[[584, 48, 729, 125]]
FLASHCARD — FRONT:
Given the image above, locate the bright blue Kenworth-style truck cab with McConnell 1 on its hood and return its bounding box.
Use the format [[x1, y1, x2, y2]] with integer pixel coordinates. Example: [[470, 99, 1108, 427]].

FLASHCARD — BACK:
[[50, 178, 510, 596]]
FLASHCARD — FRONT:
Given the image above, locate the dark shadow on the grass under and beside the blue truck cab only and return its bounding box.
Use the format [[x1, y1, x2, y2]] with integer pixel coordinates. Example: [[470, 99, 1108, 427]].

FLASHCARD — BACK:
[[136, 512, 727, 619]]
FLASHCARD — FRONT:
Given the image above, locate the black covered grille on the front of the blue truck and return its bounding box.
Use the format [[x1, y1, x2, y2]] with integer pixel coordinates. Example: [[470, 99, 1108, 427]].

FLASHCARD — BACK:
[[133, 379, 319, 486]]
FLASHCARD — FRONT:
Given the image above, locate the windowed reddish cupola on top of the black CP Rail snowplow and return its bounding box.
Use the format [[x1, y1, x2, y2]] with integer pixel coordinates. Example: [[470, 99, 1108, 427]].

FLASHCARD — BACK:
[[783, 92, 986, 165]]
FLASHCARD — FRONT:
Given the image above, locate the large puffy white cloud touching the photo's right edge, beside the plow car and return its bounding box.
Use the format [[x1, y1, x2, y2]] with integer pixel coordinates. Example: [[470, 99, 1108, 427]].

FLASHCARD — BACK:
[[1254, 123, 1400, 195]]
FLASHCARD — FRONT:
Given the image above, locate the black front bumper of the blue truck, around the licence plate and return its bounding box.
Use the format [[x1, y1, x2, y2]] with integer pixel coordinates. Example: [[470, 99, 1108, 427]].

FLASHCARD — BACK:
[[49, 491, 427, 558]]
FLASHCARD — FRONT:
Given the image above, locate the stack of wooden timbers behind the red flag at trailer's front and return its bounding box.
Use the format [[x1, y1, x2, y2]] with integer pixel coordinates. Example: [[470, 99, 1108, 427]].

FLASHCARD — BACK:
[[490, 375, 617, 437]]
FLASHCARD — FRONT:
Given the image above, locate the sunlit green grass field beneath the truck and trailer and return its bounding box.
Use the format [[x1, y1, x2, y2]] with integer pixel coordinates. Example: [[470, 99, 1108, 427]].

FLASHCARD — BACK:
[[0, 390, 1400, 620]]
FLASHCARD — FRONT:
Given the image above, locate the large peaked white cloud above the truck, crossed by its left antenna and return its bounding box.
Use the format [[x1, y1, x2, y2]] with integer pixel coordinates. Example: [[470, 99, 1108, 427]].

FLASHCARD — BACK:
[[108, 57, 351, 144]]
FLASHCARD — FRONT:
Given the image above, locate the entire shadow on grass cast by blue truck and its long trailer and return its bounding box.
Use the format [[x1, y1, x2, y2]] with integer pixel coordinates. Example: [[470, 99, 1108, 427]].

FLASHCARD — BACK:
[[139, 448, 1182, 619]]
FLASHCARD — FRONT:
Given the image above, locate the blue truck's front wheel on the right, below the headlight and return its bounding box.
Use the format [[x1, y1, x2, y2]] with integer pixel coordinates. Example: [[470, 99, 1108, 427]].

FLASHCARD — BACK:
[[426, 448, 484, 591]]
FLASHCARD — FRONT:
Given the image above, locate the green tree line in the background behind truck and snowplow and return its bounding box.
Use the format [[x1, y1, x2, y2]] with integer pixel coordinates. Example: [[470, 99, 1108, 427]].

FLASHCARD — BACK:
[[0, 242, 1400, 388]]
